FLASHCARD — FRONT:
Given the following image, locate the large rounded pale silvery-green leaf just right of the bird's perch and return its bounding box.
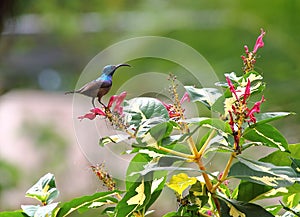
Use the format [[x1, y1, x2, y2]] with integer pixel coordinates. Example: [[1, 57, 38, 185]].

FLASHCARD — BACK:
[[124, 97, 169, 128]]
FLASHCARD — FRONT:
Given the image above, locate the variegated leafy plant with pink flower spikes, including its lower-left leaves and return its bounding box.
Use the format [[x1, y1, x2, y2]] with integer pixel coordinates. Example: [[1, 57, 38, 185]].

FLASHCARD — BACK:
[[0, 30, 300, 217]]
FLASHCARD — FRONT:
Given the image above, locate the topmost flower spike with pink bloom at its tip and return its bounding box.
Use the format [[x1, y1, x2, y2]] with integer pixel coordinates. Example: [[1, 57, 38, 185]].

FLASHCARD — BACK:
[[242, 29, 266, 73]]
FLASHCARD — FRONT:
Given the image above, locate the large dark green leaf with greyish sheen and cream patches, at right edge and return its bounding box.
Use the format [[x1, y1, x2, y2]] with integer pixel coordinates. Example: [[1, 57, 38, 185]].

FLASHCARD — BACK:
[[228, 157, 297, 188]]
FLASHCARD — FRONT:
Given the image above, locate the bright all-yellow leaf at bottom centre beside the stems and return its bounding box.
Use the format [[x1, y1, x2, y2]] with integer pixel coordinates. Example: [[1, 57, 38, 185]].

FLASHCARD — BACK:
[[167, 173, 197, 197]]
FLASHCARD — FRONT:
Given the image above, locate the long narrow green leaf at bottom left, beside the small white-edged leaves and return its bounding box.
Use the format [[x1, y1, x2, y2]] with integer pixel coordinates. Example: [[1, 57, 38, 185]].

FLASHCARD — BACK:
[[56, 190, 121, 217]]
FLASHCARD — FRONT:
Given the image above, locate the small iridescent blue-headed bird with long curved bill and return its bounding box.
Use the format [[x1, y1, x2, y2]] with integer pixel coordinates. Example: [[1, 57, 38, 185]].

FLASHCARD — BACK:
[[65, 63, 130, 108]]
